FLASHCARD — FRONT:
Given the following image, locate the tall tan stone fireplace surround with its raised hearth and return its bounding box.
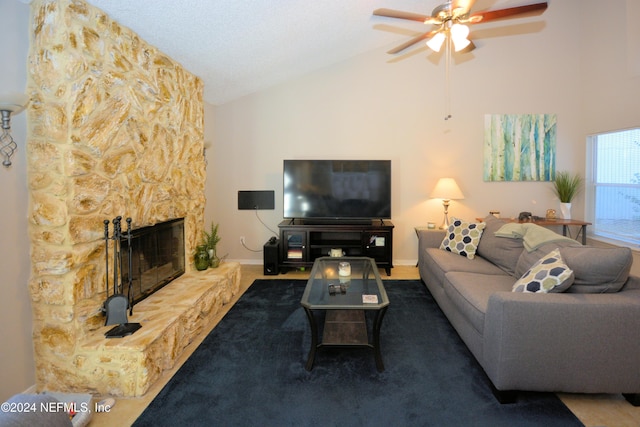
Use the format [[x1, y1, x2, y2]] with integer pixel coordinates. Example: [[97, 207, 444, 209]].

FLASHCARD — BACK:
[[27, 0, 239, 396]]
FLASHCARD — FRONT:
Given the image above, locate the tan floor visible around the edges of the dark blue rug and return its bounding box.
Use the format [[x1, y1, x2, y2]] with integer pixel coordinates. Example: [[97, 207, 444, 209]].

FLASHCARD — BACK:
[[90, 265, 640, 427]]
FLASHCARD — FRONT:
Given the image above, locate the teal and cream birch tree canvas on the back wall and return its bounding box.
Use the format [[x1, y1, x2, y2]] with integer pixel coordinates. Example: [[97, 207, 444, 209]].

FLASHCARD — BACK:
[[483, 114, 557, 181]]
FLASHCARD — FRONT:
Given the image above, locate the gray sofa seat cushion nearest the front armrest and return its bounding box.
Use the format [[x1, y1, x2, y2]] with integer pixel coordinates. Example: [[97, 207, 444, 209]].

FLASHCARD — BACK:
[[444, 272, 515, 335]]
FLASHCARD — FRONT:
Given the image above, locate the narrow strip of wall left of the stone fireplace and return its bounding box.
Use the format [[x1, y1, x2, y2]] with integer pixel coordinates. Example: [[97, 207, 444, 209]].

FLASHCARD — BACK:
[[0, 0, 35, 402]]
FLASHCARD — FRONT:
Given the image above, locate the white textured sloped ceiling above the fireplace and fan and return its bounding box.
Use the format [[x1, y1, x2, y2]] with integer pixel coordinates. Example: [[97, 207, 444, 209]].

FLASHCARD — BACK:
[[87, 0, 520, 105]]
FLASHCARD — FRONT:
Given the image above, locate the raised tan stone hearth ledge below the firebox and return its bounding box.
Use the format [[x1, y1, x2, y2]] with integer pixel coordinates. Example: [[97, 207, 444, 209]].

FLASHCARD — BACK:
[[77, 262, 240, 396]]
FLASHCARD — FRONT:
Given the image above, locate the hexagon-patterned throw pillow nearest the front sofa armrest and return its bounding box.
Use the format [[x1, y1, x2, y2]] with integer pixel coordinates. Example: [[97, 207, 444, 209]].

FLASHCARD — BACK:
[[513, 249, 574, 293]]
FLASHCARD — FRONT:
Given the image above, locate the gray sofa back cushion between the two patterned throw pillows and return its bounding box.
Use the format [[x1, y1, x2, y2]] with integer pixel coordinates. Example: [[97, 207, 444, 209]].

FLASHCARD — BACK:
[[476, 215, 524, 277]]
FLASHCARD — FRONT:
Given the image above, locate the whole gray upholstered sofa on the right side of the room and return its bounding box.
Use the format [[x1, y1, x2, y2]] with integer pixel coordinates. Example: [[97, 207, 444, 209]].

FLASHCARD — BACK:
[[417, 216, 640, 406]]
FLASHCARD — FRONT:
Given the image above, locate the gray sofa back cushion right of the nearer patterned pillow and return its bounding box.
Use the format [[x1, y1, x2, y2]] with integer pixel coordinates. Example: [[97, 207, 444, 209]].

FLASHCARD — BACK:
[[560, 246, 633, 293]]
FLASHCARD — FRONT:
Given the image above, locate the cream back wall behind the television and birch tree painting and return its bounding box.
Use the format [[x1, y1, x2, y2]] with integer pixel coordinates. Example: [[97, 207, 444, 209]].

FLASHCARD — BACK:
[[210, 0, 592, 264]]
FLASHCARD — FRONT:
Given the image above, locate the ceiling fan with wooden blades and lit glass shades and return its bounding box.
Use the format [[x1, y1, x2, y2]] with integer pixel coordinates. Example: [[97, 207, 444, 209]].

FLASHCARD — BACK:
[[373, 0, 547, 54]]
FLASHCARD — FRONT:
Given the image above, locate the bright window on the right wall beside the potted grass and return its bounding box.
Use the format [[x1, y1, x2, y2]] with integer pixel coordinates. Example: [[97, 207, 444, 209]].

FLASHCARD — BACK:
[[586, 128, 640, 248]]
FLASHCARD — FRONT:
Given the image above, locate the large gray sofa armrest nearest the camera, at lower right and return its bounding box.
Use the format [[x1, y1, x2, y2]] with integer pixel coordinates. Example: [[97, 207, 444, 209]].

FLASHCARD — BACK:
[[481, 289, 640, 393]]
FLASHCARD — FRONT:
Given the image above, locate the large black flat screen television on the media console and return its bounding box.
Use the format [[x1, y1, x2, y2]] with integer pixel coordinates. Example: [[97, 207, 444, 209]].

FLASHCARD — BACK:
[[283, 160, 391, 222]]
